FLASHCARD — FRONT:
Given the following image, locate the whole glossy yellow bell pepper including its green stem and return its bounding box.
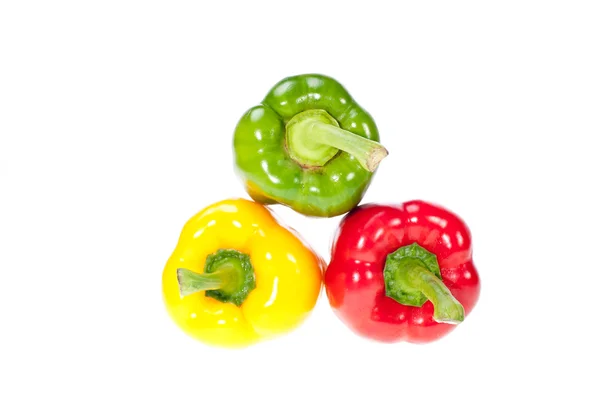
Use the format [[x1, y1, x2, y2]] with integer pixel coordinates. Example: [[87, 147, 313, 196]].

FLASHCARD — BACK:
[[162, 199, 324, 348]]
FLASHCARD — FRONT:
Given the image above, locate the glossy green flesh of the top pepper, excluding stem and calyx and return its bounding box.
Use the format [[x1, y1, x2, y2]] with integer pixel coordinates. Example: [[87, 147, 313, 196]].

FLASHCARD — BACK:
[[233, 75, 379, 217]]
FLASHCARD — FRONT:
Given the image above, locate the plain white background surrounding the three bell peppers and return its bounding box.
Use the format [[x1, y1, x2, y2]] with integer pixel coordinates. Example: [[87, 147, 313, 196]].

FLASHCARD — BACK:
[[0, 0, 600, 397]]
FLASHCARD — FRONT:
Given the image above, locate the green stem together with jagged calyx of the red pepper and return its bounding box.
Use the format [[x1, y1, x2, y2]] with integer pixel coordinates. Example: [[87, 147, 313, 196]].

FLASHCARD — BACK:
[[383, 243, 465, 324]]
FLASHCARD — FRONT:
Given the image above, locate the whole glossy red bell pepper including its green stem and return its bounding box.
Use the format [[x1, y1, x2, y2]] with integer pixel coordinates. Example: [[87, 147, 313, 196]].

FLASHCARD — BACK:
[[325, 201, 480, 343]]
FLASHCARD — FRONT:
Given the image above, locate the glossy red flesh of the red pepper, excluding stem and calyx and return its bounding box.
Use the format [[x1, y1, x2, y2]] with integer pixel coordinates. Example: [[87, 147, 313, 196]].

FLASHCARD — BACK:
[[325, 201, 480, 342]]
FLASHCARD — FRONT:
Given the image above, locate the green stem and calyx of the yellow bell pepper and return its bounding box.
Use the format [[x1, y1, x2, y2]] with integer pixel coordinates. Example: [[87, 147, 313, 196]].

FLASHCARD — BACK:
[[177, 249, 256, 307]]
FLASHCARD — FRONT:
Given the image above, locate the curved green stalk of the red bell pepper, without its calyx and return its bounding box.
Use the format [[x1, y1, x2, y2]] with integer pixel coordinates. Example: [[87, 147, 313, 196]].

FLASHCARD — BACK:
[[406, 264, 465, 324]]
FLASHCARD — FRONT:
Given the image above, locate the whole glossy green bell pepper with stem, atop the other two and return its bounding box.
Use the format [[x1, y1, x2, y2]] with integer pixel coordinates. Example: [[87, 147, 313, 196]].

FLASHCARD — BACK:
[[233, 74, 388, 217]]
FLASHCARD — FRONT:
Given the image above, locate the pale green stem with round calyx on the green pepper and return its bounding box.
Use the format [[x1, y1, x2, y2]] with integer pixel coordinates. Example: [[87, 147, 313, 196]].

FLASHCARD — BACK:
[[286, 109, 388, 172]]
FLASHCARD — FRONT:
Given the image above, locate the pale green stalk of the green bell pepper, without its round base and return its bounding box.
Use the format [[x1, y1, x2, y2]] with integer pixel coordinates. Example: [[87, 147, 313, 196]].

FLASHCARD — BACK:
[[305, 121, 388, 172]]
